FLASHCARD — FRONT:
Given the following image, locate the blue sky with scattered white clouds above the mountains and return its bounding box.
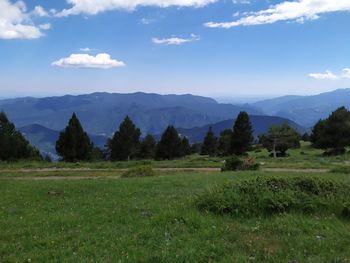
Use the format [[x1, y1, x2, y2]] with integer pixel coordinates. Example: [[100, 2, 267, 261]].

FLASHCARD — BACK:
[[0, 0, 350, 98]]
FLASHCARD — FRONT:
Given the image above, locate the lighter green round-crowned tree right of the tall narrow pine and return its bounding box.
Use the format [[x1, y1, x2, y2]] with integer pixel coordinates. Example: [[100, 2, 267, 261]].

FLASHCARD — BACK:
[[259, 123, 300, 157]]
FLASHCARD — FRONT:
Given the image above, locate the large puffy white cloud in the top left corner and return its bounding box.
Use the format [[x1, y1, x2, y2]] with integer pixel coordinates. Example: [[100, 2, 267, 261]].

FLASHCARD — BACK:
[[0, 0, 47, 39]]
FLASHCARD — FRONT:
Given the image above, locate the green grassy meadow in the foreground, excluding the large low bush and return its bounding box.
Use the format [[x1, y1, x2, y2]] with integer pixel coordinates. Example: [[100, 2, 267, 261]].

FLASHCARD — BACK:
[[0, 172, 350, 262]]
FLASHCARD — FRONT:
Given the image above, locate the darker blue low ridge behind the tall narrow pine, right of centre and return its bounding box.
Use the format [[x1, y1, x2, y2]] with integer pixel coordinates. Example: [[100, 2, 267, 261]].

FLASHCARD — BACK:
[[178, 115, 306, 143]]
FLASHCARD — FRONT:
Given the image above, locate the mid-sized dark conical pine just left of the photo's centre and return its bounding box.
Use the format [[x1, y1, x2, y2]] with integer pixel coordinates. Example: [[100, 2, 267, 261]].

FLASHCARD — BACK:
[[156, 126, 183, 160]]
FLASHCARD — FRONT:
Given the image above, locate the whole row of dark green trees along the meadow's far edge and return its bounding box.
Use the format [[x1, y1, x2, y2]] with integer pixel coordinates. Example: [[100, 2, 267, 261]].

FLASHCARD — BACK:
[[0, 107, 350, 162]]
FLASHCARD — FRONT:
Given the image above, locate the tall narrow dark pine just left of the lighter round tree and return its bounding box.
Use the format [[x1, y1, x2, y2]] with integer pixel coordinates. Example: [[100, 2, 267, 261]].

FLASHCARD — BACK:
[[230, 111, 254, 155]]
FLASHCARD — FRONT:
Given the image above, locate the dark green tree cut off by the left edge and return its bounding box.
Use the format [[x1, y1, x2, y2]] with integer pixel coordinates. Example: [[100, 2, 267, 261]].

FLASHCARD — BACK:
[[0, 112, 42, 160]]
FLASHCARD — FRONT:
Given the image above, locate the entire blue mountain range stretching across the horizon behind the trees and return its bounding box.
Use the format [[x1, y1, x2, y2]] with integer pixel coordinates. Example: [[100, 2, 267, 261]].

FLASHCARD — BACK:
[[0, 89, 350, 155]]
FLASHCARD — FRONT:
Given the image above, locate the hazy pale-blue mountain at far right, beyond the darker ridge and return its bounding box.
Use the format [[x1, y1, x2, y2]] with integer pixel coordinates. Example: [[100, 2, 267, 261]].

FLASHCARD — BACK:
[[251, 89, 350, 127]]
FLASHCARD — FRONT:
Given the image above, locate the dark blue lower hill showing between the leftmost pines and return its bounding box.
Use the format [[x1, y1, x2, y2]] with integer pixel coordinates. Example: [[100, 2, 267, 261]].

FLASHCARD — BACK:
[[18, 124, 107, 159]]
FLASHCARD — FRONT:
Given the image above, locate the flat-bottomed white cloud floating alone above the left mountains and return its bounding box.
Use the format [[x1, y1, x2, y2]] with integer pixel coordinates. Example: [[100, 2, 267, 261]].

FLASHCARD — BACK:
[[52, 53, 125, 69]]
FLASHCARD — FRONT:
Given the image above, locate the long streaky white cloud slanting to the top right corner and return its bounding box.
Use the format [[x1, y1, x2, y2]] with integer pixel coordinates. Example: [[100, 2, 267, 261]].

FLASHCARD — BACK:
[[205, 0, 350, 28]]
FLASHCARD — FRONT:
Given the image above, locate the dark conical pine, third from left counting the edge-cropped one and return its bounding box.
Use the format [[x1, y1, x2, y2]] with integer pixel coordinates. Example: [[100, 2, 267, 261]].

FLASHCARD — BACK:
[[109, 116, 141, 161]]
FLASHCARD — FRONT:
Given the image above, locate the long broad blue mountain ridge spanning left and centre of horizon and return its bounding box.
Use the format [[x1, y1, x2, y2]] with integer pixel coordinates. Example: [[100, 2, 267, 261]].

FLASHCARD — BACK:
[[0, 93, 263, 136]]
